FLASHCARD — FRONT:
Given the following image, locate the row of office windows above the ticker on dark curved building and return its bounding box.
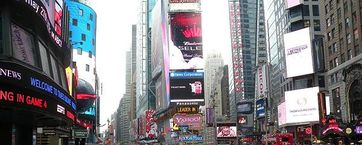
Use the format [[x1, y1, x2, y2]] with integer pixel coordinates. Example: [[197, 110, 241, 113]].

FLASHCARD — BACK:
[[0, 21, 68, 90]]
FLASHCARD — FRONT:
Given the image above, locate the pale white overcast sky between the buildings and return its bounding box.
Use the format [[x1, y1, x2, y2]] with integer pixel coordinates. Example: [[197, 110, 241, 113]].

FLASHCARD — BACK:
[[91, 0, 231, 130]]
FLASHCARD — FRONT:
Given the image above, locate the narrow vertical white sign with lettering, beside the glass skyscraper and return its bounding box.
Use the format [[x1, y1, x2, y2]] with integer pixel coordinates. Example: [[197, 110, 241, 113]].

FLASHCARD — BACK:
[[256, 65, 267, 97]]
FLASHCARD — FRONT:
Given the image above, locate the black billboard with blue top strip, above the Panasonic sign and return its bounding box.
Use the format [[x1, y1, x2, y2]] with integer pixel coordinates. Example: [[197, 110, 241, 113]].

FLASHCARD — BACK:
[[170, 72, 204, 105]]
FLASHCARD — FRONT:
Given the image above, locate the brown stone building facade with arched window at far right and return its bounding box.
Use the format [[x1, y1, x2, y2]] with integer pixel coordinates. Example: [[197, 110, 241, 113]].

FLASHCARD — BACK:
[[320, 0, 362, 123]]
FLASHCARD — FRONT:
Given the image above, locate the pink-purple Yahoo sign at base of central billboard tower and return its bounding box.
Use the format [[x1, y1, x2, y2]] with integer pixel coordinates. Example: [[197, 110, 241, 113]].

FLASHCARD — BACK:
[[173, 114, 203, 130]]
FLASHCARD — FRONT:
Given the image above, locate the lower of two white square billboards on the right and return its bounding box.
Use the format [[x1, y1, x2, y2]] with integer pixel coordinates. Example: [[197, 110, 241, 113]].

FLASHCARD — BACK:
[[285, 87, 319, 124]]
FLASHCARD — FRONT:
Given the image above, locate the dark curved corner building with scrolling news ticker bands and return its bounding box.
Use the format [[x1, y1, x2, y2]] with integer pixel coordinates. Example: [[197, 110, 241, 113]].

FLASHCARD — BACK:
[[0, 0, 77, 145]]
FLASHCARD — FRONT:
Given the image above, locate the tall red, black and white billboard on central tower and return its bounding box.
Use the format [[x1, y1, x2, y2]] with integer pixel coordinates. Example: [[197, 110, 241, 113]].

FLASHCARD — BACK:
[[169, 12, 204, 70]]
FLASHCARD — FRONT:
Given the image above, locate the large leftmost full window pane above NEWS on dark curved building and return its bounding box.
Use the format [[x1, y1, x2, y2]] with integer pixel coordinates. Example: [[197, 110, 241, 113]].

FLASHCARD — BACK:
[[11, 24, 35, 66]]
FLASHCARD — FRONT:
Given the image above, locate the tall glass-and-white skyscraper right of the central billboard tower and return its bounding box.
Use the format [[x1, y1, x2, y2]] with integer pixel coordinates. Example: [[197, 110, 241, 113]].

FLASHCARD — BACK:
[[229, 0, 267, 138]]
